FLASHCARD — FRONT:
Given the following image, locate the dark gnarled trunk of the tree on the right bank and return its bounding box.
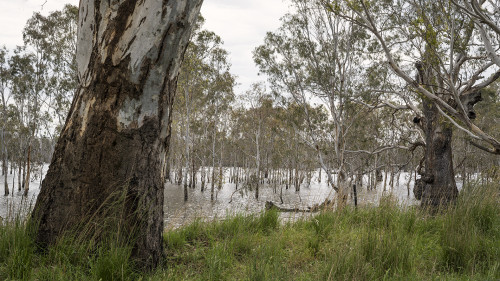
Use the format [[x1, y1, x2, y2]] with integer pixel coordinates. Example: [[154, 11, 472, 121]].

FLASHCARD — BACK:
[[421, 100, 458, 206]]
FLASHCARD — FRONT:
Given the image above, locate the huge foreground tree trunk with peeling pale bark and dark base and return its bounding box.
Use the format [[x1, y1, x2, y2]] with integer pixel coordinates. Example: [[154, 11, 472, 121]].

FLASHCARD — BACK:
[[33, 0, 203, 267]]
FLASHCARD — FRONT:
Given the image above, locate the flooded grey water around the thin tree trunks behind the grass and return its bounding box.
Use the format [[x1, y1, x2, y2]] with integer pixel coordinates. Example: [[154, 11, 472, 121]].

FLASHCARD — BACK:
[[0, 165, 426, 229]]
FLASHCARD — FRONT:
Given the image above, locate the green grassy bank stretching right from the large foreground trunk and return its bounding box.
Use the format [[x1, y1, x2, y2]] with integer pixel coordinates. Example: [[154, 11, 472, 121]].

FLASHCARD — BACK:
[[158, 185, 500, 280]]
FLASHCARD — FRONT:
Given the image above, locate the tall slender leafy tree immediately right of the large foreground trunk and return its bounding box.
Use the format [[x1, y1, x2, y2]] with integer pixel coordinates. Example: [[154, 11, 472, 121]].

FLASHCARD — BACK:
[[174, 17, 235, 200]]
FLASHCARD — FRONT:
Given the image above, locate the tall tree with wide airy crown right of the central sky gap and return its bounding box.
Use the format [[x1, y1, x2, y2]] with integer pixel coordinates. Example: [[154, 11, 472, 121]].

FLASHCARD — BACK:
[[254, 0, 390, 201]]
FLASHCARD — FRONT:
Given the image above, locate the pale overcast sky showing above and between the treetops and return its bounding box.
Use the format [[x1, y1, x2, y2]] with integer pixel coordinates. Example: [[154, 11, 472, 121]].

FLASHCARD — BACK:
[[0, 0, 288, 92]]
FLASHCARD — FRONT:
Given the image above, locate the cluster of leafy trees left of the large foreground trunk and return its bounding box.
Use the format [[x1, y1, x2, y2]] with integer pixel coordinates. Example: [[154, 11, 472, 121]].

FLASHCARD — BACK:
[[0, 5, 78, 194]]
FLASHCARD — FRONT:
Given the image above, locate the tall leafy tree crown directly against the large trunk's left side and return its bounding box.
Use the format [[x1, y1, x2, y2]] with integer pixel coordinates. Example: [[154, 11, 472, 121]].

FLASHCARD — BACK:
[[23, 4, 78, 135]]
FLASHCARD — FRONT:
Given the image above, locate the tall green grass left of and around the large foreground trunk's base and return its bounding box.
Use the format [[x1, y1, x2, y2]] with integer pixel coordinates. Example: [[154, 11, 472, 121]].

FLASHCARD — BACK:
[[0, 212, 138, 280]]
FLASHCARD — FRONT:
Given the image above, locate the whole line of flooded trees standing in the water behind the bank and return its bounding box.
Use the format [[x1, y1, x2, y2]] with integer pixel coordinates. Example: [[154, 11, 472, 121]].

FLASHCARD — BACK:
[[0, 0, 500, 206]]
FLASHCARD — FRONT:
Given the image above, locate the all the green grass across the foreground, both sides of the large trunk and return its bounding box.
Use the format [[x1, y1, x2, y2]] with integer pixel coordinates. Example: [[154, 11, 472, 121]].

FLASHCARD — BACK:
[[0, 182, 500, 280]]
